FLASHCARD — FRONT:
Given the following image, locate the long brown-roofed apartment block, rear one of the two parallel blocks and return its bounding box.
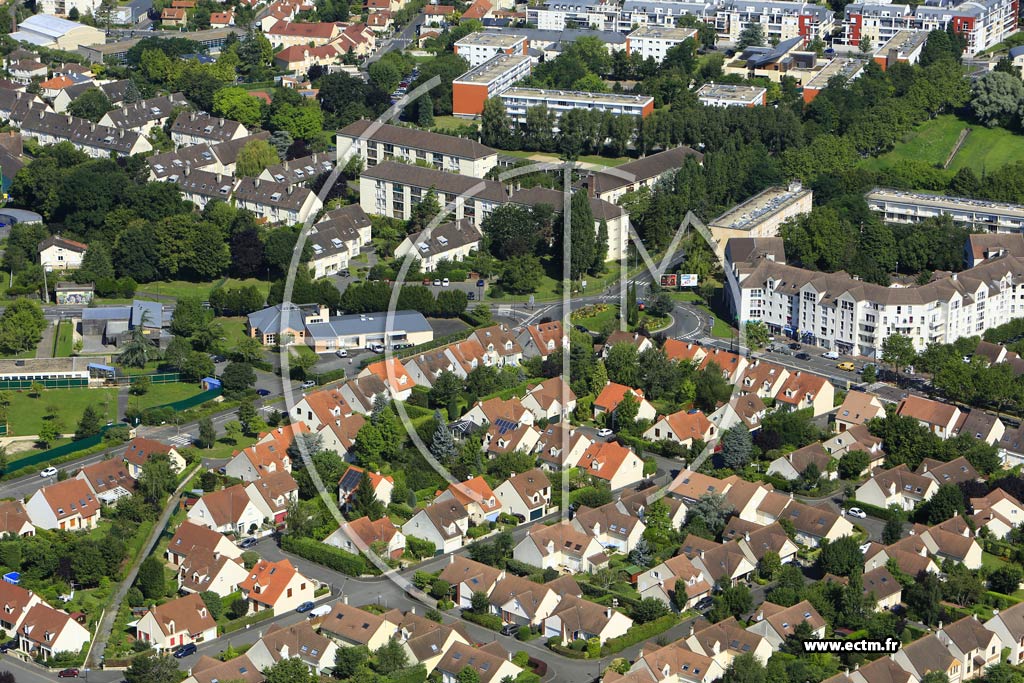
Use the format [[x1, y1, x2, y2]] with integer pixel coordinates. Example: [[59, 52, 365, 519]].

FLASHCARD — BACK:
[[338, 119, 498, 178]]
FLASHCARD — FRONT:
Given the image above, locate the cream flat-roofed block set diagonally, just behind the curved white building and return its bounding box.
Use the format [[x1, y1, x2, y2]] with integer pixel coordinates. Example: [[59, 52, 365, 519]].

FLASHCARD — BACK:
[[708, 182, 813, 257]]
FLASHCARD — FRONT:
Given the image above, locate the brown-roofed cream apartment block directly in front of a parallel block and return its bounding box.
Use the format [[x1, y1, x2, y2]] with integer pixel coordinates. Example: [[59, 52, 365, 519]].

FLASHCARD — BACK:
[[359, 161, 509, 227]]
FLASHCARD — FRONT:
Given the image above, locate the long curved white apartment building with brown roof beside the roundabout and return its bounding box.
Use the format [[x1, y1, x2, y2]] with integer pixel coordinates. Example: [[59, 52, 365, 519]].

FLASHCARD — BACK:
[[725, 239, 1024, 357]]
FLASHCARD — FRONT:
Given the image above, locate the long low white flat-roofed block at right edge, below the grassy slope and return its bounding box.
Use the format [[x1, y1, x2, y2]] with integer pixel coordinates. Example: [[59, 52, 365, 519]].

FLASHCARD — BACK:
[[864, 187, 1024, 232]]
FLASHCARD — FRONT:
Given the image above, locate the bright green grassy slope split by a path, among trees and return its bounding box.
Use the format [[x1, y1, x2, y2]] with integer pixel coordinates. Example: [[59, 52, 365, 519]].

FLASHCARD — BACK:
[[861, 115, 1024, 175]]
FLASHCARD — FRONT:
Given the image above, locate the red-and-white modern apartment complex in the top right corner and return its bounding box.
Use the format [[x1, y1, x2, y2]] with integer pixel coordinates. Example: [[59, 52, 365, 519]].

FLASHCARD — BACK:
[[843, 0, 1019, 56]]
